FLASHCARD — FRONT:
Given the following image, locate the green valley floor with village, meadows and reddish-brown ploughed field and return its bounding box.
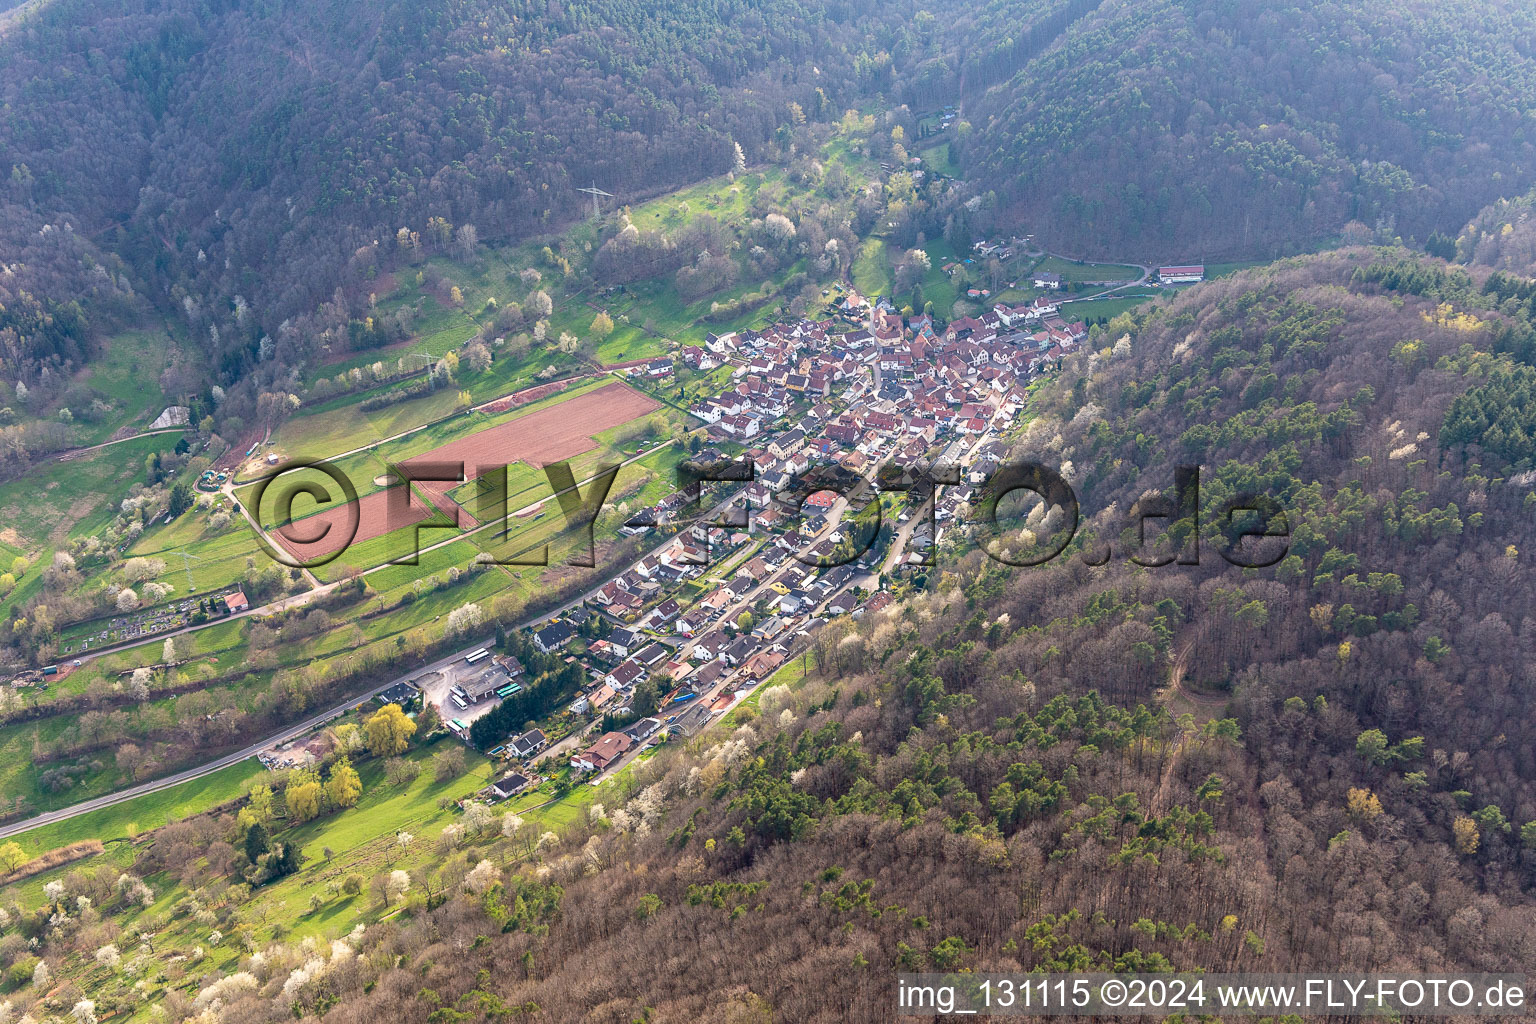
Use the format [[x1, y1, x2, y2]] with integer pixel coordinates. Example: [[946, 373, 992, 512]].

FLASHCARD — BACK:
[[0, 104, 1223, 1000]]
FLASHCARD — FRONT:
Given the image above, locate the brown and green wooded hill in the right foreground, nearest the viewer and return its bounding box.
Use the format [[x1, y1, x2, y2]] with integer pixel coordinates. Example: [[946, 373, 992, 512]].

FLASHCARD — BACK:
[[56, 250, 1536, 1024]]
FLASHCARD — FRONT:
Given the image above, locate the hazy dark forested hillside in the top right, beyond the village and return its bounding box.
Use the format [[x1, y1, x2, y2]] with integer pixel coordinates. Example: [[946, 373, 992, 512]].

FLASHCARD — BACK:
[[965, 0, 1536, 258]]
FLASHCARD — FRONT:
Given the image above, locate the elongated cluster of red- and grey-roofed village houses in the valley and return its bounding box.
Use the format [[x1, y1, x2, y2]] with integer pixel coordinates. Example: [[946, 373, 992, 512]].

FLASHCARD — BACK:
[[339, 254, 1204, 801]]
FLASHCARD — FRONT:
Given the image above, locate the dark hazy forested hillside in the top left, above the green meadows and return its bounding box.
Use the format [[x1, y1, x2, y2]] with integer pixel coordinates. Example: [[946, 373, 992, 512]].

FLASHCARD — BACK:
[[0, 0, 920, 387]]
